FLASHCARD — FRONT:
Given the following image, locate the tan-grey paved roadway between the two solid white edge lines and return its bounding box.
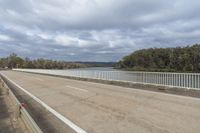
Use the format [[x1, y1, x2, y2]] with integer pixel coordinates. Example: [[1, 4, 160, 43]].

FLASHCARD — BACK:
[[2, 71, 200, 133]]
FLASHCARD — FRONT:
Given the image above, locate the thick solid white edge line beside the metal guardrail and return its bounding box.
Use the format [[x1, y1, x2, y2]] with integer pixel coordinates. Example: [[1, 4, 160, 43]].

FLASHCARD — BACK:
[[1, 73, 87, 133]]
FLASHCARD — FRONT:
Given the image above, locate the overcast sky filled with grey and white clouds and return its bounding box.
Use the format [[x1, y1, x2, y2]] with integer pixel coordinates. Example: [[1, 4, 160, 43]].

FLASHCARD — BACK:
[[0, 0, 200, 61]]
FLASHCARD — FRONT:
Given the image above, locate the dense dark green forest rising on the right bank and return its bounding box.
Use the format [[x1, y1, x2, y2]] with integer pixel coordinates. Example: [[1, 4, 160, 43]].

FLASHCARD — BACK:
[[117, 44, 200, 72]]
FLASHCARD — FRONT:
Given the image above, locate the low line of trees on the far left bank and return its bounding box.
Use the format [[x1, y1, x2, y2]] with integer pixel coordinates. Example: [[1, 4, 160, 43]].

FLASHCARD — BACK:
[[0, 54, 87, 69]]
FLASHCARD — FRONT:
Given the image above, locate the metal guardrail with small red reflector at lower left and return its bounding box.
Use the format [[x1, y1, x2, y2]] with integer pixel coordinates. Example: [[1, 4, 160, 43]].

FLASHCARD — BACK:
[[0, 75, 42, 133]]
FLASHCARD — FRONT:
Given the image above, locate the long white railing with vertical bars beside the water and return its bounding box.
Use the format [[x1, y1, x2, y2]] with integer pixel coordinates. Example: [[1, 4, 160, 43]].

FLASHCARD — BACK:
[[14, 69, 200, 89]]
